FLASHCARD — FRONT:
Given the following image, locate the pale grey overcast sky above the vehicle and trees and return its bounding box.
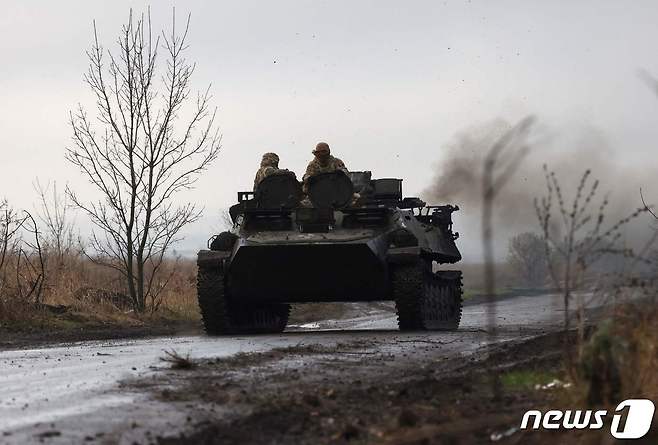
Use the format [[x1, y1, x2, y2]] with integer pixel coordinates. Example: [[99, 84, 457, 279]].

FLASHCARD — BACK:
[[0, 0, 658, 261]]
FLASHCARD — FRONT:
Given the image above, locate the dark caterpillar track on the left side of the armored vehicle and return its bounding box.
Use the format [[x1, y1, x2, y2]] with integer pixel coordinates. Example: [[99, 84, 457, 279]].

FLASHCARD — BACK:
[[197, 265, 290, 335]]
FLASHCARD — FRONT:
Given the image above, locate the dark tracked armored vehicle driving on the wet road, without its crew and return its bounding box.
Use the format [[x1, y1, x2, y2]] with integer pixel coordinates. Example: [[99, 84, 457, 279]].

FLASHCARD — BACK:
[[197, 171, 462, 335]]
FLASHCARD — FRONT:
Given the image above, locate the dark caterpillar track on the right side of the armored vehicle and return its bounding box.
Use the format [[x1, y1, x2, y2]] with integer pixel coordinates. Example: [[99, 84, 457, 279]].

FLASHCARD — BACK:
[[391, 261, 462, 330]]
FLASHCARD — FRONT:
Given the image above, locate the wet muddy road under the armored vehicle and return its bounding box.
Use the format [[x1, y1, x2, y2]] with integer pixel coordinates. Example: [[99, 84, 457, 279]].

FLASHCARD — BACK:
[[0, 295, 563, 444]]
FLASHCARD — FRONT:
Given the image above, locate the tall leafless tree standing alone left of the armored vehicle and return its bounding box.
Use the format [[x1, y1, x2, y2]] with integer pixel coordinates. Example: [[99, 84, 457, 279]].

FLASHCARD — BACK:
[[66, 11, 221, 311]]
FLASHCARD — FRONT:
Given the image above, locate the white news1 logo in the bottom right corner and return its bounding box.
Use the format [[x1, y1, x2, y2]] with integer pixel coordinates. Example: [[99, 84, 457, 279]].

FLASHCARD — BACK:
[[521, 399, 656, 439]]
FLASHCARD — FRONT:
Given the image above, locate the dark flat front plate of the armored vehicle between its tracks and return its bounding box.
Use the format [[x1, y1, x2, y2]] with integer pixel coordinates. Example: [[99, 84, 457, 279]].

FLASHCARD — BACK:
[[227, 236, 390, 303]]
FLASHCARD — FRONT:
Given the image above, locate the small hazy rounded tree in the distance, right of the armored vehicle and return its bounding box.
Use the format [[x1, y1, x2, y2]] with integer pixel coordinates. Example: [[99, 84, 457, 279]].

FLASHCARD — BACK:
[[507, 232, 548, 287]]
